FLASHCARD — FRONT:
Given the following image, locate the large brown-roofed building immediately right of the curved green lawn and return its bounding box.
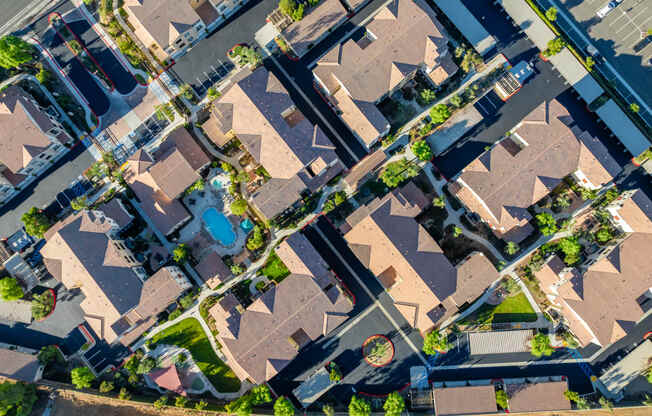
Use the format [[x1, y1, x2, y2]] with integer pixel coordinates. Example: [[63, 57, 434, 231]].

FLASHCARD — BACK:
[[209, 233, 352, 384]]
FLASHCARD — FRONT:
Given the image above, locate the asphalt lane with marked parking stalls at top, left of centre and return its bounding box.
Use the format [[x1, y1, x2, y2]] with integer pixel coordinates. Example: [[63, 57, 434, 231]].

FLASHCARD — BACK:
[[171, 0, 278, 96]]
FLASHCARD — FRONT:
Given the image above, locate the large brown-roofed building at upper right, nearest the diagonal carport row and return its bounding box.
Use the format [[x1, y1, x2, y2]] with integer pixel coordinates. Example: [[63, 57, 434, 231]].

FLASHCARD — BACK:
[[454, 100, 621, 242]]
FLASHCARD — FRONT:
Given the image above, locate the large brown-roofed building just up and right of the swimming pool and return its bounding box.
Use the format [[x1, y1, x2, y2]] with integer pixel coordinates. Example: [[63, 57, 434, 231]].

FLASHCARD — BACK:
[[213, 68, 344, 219]]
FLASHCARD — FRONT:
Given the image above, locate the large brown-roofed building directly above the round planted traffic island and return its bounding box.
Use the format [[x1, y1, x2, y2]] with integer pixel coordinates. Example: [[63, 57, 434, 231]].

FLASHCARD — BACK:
[[342, 182, 498, 333]]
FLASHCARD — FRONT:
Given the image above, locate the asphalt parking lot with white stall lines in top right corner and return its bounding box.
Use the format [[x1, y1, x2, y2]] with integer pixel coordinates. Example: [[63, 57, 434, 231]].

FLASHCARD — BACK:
[[557, 0, 652, 120]]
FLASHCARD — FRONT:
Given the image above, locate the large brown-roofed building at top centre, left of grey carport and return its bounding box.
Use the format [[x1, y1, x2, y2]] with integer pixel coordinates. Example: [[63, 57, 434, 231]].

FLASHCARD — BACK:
[[313, 0, 457, 147]]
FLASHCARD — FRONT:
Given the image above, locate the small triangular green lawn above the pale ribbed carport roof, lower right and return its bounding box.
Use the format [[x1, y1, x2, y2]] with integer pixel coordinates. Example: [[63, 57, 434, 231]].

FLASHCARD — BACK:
[[460, 293, 537, 325]]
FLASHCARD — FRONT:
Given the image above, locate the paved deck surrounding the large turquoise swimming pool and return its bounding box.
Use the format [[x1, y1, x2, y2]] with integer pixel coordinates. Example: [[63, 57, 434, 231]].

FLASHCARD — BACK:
[[179, 171, 247, 256]]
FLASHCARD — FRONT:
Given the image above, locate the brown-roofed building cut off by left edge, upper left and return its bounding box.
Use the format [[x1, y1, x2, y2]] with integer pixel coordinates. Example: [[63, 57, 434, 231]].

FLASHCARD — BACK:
[[0, 86, 55, 173]]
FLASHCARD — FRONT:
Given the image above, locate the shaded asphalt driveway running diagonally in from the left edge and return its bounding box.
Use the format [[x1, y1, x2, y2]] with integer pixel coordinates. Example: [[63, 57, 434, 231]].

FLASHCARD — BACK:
[[0, 142, 95, 238]]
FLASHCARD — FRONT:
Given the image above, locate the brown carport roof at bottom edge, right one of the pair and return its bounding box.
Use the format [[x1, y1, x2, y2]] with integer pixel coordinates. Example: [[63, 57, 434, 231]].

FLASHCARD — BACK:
[[507, 381, 571, 412]]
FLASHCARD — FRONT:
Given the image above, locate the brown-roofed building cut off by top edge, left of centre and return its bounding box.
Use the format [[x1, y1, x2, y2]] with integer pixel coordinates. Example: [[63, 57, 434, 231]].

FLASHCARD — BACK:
[[125, 0, 200, 48]]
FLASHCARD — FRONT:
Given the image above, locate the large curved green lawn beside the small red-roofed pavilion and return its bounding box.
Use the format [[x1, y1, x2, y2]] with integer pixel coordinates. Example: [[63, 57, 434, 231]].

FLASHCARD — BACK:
[[152, 318, 240, 392]]
